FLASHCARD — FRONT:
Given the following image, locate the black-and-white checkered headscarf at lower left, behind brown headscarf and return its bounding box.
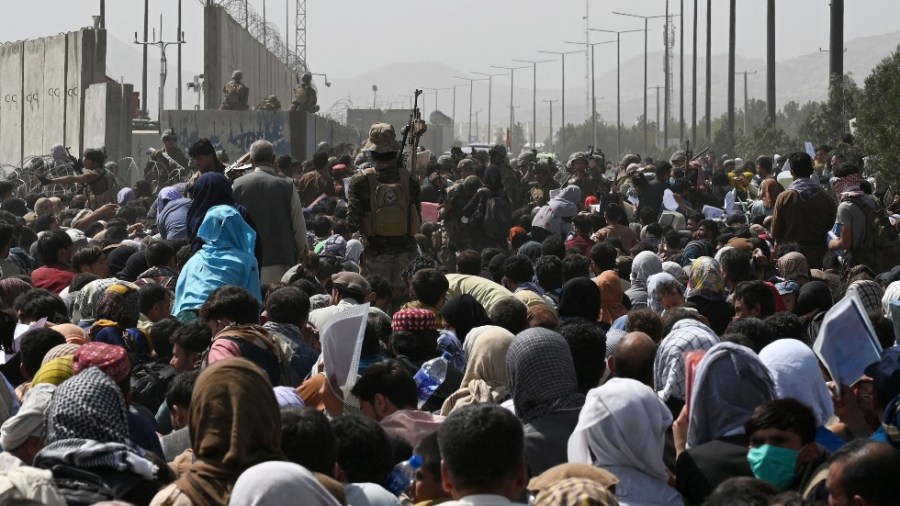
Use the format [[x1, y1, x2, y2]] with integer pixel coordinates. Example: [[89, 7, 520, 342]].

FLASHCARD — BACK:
[[45, 367, 131, 445]]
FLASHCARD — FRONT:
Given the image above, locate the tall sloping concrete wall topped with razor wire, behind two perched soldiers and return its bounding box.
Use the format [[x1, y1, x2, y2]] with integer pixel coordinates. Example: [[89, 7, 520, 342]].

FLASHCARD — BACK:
[[203, 5, 297, 110]]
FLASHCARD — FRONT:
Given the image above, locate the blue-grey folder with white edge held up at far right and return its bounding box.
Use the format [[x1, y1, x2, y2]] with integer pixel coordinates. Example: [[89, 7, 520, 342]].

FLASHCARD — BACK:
[[813, 294, 881, 393]]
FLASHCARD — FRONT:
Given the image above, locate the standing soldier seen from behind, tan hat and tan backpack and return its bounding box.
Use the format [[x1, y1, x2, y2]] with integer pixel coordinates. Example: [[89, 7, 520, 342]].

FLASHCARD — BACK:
[[347, 123, 422, 307]]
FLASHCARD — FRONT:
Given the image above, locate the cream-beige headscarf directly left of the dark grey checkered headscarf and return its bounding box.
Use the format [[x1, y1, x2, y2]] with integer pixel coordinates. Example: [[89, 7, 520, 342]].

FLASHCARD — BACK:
[[441, 324, 513, 415]]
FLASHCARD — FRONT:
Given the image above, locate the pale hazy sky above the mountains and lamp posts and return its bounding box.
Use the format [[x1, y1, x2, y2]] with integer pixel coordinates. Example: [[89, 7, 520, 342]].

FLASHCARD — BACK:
[[7, 0, 900, 119]]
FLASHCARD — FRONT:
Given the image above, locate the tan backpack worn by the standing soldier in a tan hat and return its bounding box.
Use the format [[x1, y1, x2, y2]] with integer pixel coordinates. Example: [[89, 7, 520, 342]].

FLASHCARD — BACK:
[[363, 168, 421, 237]]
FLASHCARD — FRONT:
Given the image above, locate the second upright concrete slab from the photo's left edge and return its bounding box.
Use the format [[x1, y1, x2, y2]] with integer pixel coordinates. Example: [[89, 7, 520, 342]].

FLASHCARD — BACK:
[[22, 39, 46, 158]]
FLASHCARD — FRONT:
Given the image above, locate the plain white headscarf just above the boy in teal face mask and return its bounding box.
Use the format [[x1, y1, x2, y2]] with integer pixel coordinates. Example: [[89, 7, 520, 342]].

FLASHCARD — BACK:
[[759, 339, 834, 425]]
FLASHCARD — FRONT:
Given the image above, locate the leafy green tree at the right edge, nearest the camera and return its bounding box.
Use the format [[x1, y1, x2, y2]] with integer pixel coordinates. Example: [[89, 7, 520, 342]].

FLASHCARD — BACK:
[[851, 45, 900, 188]]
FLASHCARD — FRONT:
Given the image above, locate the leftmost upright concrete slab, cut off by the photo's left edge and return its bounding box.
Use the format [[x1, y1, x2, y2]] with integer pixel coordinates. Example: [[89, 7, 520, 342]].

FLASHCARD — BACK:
[[0, 42, 23, 165]]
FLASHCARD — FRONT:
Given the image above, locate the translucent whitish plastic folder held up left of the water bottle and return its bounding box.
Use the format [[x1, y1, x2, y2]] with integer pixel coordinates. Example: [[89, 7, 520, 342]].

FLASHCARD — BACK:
[[319, 304, 369, 387]]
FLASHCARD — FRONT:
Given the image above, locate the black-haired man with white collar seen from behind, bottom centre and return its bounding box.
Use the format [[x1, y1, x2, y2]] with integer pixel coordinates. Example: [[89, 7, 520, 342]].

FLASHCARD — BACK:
[[438, 404, 527, 506]]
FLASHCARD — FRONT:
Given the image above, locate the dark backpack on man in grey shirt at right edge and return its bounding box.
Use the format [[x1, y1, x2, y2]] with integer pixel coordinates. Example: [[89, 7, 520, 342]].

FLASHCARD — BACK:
[[847, 197, 900, 272]]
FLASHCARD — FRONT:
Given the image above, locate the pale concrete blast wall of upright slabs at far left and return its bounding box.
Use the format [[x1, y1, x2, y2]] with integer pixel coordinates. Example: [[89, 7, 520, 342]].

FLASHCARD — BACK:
[[0, 29, 106, 165]]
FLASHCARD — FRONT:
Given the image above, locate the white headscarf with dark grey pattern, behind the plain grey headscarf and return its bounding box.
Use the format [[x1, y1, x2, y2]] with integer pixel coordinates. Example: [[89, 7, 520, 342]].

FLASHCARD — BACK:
[[653, 318, 719, 401]]
